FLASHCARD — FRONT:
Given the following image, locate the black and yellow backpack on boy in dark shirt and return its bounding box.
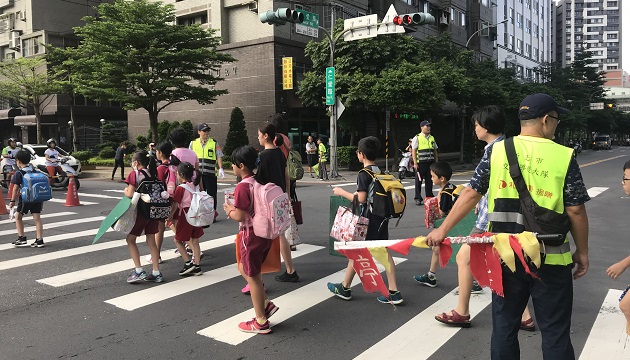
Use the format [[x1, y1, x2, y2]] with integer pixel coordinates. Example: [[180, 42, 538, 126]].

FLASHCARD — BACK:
[[359, 168, 407, 226]]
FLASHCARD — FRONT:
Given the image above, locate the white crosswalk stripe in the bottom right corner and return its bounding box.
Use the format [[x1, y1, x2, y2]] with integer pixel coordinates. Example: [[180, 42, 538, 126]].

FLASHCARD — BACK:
[[579, 289, 630, 360]]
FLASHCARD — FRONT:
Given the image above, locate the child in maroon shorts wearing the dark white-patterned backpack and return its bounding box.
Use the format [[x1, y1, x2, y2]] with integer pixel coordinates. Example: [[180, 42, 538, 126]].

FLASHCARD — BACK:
[[125, 150, 164, 283]]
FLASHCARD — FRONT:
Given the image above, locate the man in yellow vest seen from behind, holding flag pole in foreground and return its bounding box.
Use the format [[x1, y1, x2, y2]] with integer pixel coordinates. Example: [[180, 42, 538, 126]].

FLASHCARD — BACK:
[[427, 94, 590, 359]]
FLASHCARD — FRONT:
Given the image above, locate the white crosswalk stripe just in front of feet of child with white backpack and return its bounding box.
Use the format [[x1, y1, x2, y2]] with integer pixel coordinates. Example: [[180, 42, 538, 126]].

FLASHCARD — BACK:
[[105, 243, 324, 311]]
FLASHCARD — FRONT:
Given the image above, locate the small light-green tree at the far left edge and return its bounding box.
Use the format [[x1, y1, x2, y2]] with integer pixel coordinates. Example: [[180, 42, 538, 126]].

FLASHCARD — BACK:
[[0, 56, 59, 144]]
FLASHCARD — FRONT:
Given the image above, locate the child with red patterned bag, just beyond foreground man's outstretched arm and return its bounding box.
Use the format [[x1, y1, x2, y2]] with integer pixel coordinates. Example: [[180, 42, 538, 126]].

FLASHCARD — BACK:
[[413, 161, 456, 287]]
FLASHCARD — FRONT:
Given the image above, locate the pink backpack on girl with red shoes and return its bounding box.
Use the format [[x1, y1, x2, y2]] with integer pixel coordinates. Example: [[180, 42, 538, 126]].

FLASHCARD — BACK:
[[242, 177, 291, 239]]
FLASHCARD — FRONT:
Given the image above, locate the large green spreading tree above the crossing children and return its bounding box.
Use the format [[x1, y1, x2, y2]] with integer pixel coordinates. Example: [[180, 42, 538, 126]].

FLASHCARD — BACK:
[[67, 0, 234, 142]]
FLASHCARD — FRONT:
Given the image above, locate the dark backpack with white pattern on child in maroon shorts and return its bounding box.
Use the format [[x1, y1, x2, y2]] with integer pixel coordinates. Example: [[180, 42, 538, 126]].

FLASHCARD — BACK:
[[136, 170, 171, 220]]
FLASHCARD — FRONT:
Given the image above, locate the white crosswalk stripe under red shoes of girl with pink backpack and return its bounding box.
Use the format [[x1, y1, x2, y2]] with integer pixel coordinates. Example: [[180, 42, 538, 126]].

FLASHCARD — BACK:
[[197, 258, 410, 344]]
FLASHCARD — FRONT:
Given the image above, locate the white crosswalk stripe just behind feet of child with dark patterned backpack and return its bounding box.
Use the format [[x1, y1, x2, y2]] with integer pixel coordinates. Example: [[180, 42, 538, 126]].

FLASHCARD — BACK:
[[37, 233, 236, 287]]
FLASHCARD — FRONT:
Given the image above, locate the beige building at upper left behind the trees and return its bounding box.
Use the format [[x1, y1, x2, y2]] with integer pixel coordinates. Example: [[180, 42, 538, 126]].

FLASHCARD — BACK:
[[0, 0, 127, 148]]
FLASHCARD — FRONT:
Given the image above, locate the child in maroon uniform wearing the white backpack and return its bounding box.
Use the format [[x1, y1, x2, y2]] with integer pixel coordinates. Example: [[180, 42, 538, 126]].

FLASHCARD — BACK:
[[168, 162, 203, 276]]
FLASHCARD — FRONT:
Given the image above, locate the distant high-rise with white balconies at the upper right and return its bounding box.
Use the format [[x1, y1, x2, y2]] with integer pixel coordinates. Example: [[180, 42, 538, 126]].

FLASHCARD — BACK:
[[552, 0, 621, 71]]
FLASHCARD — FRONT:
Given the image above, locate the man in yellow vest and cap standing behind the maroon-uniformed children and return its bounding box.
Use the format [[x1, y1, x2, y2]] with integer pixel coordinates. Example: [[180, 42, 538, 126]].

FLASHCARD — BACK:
[[188, 123, 225, 219]]
